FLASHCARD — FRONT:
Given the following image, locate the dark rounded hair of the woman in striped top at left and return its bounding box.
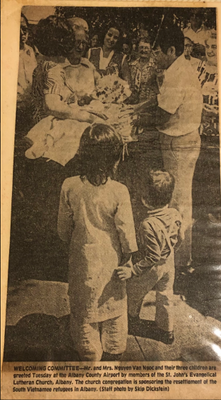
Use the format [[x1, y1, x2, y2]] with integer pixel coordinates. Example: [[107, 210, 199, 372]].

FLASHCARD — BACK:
[[35, 15, 75, 57]]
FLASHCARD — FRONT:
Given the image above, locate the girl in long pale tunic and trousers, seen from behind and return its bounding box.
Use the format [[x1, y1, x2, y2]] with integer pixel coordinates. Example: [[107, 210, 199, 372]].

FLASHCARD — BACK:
[[58, 124, 137, 361]]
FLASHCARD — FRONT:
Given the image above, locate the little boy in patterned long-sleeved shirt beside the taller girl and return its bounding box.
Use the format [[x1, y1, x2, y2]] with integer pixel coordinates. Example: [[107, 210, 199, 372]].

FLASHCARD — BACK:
[[118, 170, 181, 344]]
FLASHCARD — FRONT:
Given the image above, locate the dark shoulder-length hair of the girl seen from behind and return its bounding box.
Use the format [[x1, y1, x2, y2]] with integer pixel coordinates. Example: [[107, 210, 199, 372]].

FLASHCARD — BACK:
[[78, 124, 123, 186]]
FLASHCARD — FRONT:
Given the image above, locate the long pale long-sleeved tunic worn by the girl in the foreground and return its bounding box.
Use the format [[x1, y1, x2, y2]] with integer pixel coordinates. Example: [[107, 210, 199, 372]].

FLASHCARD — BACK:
[[58, 176, 137, 323]]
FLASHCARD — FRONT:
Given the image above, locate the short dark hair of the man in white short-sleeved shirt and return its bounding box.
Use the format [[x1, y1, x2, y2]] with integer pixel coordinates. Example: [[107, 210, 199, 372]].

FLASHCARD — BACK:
[[155, 25, 184, 57]]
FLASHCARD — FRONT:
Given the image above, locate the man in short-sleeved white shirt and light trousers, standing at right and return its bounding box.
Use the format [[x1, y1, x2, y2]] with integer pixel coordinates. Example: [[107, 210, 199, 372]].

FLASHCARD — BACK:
[[150, 26, 202, 267]]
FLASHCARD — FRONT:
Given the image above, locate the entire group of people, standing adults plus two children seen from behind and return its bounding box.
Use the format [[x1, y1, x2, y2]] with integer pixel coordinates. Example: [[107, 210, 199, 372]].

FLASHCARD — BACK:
[[16, 9, 219, 361]]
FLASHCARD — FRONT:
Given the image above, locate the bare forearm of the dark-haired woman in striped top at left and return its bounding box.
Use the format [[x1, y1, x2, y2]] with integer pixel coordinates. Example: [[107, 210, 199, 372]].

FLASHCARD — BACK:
[[44, 93, 95, 124]]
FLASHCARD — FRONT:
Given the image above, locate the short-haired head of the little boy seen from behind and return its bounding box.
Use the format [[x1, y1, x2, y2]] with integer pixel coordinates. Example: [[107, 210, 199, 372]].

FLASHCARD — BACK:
[[142, 170, 175, 208]]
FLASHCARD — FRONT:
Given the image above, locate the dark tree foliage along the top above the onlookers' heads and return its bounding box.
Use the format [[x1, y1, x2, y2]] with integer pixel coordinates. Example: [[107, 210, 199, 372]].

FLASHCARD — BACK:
[[56, 7, 216, 40]]
